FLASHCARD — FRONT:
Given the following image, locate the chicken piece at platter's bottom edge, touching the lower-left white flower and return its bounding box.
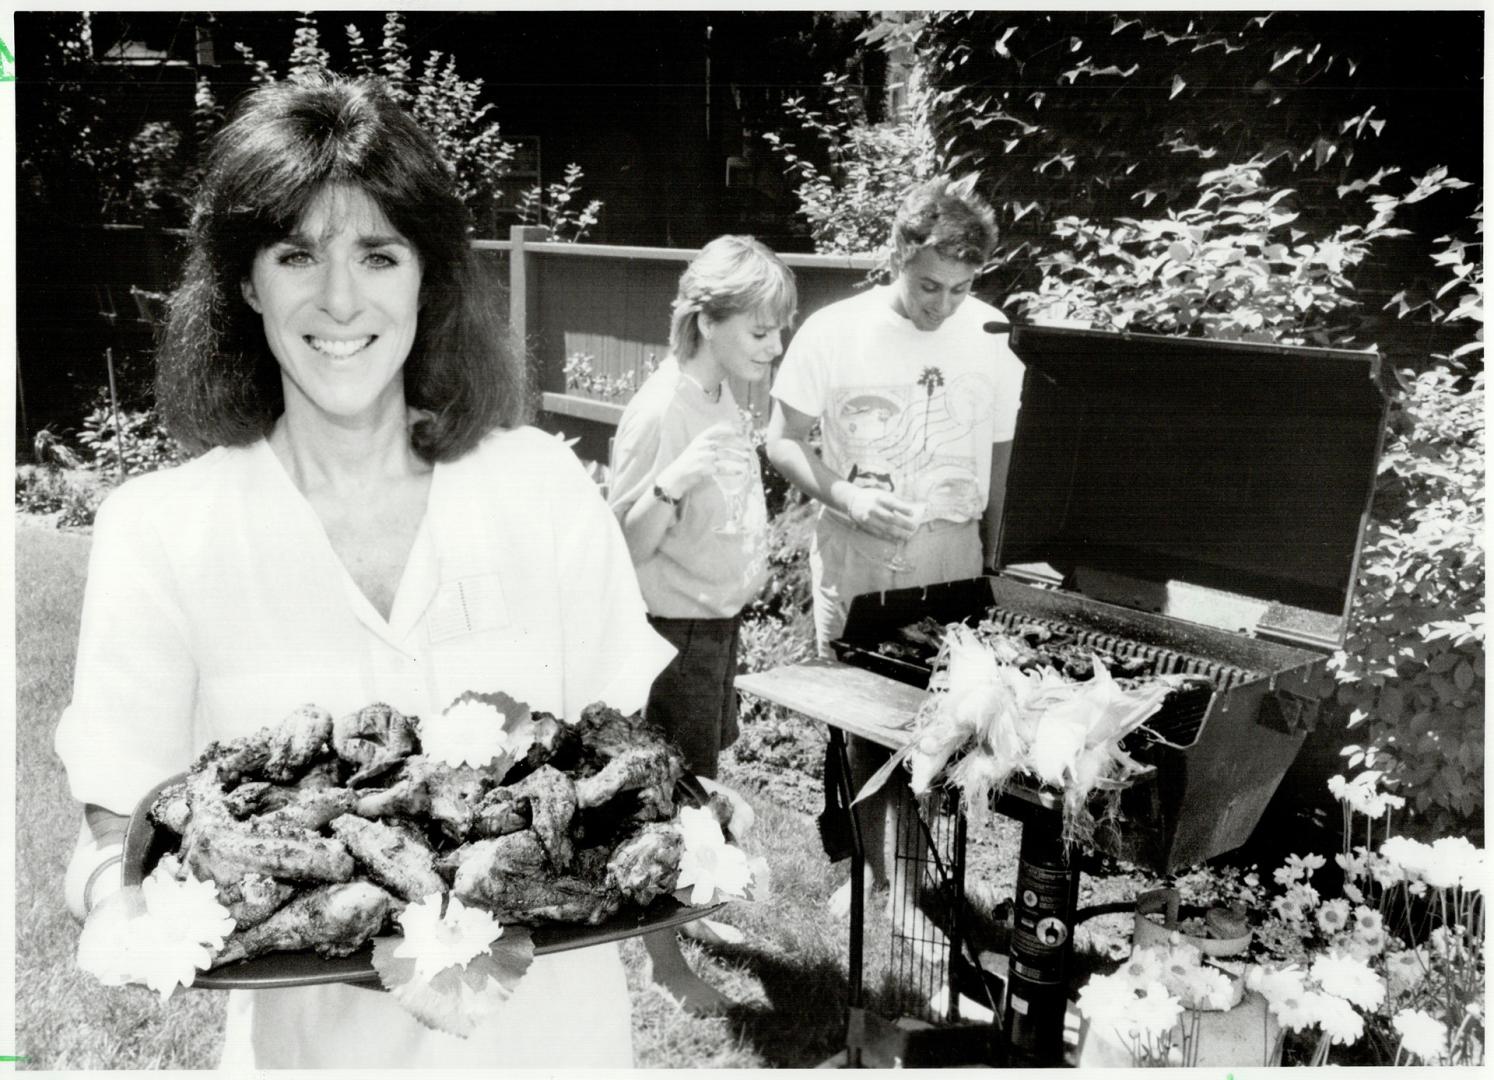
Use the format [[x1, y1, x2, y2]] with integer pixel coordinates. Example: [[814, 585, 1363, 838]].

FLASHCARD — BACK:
[[217, 881, 393, 963]]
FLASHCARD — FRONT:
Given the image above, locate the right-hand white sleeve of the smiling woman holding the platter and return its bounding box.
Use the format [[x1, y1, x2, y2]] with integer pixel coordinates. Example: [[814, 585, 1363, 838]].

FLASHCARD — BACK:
[[551, 439, 674, 721]]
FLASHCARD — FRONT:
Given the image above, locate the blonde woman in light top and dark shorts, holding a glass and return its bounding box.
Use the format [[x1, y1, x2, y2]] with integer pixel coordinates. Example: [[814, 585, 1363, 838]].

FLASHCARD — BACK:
[[610, 236, 798, 1014]]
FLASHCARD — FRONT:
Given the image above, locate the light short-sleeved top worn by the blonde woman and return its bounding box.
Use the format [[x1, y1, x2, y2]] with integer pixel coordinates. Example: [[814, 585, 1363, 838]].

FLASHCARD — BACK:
[[608, 356, 768, 618]]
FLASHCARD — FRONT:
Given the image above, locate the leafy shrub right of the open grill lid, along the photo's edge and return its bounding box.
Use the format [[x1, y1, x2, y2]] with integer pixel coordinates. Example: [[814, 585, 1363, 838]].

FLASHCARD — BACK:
[[1333, 209, 1485, 837]]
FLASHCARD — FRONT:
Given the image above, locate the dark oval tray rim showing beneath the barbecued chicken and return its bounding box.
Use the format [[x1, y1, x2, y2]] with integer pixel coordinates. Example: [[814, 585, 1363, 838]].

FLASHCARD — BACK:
[[121, 774, 725, 990]]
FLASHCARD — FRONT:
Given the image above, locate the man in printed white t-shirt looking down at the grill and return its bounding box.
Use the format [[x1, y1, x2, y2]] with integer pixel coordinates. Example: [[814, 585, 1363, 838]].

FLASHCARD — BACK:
[[768, 176, 1023, 910]]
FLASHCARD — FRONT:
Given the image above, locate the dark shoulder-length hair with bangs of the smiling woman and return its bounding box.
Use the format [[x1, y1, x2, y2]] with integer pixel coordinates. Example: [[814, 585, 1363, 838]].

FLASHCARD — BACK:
[[155, 79, 526, 462]]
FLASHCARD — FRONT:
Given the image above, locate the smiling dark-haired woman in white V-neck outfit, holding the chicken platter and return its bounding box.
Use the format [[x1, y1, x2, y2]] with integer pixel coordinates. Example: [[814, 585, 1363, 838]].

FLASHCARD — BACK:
[[57, 82, 672, 1068]]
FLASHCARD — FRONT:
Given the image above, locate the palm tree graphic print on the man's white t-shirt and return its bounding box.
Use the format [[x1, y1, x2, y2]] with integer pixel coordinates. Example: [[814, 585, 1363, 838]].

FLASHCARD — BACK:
[[823, 366, 995, 521]]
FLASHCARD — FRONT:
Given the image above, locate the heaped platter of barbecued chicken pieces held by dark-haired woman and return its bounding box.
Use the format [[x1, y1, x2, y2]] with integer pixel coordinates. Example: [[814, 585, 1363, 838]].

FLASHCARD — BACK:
[[124, 699, 732, 989]]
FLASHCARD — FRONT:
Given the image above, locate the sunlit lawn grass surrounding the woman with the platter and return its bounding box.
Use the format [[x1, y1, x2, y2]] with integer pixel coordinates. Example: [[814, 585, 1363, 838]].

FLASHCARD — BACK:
[[15, 517, 968, 1070]]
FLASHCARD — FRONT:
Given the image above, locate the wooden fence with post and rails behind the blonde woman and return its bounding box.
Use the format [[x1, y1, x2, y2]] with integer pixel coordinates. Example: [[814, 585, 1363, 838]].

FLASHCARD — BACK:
[[475, 226, 875, 459]]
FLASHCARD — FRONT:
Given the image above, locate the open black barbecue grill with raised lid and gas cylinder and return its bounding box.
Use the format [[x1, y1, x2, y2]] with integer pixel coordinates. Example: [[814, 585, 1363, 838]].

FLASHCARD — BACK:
[[834, 327, 1386, 1064]]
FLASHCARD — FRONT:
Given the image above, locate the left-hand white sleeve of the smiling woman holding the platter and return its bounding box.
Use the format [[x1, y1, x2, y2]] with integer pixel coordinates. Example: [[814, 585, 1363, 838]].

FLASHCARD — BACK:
[[54, 484, 197, 814]]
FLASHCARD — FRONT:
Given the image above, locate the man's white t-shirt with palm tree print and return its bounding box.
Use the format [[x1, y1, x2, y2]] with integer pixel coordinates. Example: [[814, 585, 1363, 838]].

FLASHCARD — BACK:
[[772, 285, 1023, 521]]
